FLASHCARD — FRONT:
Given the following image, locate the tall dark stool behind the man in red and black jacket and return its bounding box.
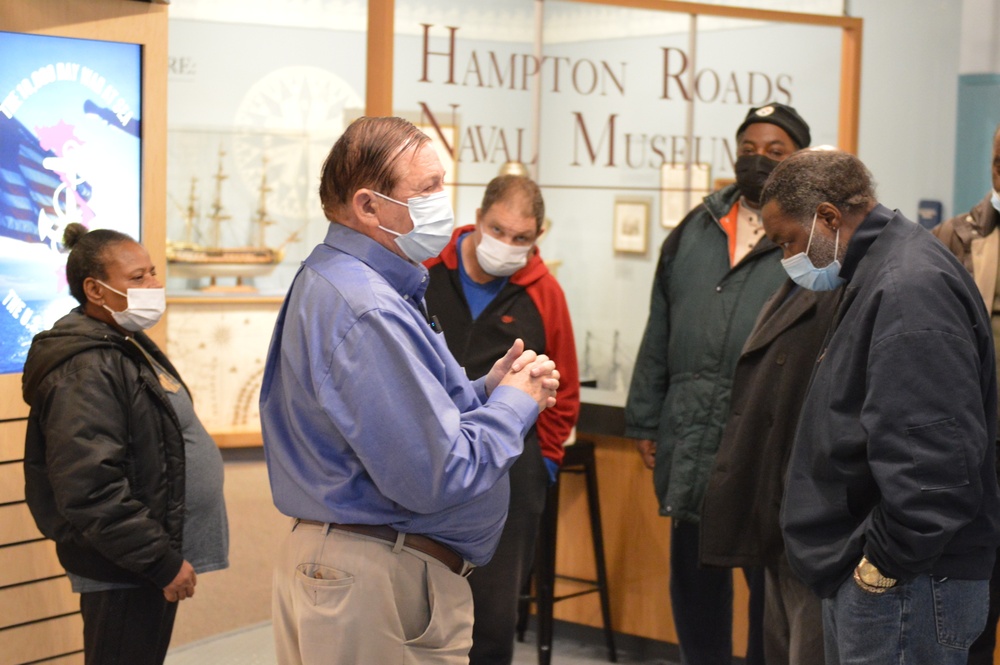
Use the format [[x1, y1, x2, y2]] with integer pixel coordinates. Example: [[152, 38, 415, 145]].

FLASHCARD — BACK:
[[517, 440, 618, 665]]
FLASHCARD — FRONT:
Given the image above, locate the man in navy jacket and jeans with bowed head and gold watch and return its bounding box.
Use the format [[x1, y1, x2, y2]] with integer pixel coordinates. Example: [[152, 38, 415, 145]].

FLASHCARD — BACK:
[[761, 151, 1000, 665]]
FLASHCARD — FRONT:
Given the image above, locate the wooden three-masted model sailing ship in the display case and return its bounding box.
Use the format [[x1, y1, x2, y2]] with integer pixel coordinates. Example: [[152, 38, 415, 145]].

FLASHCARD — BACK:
[[166, 148, 297, 291]]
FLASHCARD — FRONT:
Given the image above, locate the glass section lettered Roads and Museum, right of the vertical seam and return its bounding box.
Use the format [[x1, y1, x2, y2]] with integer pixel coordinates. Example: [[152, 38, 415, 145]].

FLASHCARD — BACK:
[[539, 1, 841, 391]]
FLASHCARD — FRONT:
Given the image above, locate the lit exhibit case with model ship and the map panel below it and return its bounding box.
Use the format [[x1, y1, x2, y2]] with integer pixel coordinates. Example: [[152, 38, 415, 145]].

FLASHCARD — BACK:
[[166, 5, 367, 438]]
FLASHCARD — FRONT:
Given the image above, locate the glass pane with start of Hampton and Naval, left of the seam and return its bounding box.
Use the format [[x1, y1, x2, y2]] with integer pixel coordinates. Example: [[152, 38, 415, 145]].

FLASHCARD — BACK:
[[393, 0, 538, 224]]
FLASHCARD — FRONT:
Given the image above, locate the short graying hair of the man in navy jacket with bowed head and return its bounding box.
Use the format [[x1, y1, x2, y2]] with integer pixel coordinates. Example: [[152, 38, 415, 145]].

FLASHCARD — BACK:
[[760, 149, 878, 224]]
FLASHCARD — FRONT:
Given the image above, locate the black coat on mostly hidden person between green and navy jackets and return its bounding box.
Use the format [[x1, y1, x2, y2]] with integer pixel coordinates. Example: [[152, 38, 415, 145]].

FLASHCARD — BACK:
[[701, 280, 840, 568]]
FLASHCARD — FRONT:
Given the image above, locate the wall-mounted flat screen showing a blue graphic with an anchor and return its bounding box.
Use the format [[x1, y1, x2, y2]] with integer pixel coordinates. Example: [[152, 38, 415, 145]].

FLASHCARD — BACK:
[[0, 31, 142, 374]]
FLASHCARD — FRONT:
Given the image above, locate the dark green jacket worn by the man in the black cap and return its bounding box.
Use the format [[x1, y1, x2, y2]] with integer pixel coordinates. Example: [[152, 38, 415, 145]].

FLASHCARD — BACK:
[[625, 185, 787, 522]]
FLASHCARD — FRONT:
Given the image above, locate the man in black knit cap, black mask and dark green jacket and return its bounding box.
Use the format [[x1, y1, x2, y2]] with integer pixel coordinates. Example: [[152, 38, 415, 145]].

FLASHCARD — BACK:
[[625, 103, 810, 665]]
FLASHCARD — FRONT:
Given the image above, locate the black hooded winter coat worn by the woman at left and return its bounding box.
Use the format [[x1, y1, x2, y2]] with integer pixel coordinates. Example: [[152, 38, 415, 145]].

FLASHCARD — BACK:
[[22, 308, 184, 588]]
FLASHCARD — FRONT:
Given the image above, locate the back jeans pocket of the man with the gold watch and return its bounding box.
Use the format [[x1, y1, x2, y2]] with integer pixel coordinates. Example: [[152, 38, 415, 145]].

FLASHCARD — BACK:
[[931, 577, 990, 649]]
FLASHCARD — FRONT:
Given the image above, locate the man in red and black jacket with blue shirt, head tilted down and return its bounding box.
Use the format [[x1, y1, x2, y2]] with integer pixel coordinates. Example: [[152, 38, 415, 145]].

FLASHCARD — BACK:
[[424, 175, 580, 665]]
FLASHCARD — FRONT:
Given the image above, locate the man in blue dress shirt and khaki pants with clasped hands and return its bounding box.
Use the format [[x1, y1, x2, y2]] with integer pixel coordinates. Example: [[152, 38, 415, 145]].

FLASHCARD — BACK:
[[260, 118, 559, 664]]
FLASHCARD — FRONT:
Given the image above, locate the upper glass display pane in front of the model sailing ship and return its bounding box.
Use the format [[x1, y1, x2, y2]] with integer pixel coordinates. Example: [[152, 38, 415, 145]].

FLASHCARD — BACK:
[[167, 9, 367, 297]]
